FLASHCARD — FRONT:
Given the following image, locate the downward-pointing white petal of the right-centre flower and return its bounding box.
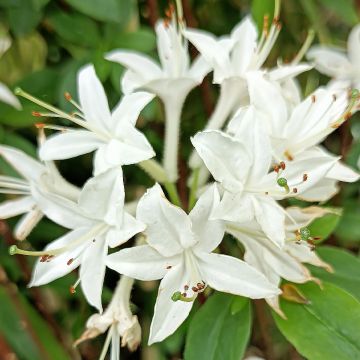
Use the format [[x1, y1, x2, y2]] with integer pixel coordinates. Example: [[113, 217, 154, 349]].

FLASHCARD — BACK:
[[253, 195, 285, 247]]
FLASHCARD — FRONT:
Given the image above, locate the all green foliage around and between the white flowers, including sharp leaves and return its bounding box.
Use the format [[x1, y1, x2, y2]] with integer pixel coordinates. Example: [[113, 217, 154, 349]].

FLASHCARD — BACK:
[[0, 0, 360, 360]]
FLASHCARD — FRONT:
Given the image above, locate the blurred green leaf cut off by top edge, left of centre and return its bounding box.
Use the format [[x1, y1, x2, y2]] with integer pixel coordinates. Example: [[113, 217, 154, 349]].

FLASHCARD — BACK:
[[67, 0, 131, 22]]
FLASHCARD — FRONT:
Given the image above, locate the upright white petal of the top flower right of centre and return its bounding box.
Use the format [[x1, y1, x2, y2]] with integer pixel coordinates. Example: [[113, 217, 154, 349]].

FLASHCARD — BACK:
[[231, 16, 258, 75]]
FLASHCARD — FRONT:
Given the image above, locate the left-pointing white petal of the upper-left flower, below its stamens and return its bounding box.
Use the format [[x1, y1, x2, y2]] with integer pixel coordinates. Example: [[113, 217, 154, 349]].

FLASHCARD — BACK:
[[39, 130, 103, 160]]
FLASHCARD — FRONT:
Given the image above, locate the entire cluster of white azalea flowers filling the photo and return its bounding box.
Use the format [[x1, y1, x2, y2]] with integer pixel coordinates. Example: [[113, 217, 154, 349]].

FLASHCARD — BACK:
[[0, 3, 359, 358]]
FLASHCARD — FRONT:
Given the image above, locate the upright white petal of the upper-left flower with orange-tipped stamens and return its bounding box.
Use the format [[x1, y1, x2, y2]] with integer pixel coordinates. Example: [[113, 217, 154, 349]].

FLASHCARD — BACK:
[[77, 65, 111, 130]]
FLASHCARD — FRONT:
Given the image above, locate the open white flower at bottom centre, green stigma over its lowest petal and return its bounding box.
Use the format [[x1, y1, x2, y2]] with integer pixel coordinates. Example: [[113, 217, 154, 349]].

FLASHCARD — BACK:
[[107, 185, 279, 344]]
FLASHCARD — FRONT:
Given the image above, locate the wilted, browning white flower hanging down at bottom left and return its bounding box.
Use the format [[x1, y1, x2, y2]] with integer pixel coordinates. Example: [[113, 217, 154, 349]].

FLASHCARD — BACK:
[[75, 276, 141, 360]]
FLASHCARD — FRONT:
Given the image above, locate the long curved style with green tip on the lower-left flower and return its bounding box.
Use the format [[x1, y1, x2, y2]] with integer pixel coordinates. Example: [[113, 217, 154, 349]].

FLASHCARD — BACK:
[[9, 223, 108, 256]]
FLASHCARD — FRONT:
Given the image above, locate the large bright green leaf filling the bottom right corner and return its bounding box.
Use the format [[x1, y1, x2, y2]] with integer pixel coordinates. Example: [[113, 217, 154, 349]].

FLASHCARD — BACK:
[[273, 283, 360, 360]]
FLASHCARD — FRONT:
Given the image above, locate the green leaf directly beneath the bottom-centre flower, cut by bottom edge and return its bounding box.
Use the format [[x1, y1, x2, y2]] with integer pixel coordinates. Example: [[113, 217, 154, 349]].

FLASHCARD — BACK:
[[185, 292, 251, 360]]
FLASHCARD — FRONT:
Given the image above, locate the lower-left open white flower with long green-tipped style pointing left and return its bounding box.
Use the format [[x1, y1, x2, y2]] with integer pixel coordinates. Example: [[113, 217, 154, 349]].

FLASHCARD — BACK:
[[11, 168, 144, 311]]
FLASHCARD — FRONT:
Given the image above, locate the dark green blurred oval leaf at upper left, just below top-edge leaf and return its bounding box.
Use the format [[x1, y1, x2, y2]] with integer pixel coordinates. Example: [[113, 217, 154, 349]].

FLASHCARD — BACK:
[[47, 11, 100, 47]]
